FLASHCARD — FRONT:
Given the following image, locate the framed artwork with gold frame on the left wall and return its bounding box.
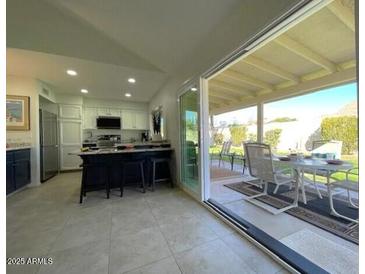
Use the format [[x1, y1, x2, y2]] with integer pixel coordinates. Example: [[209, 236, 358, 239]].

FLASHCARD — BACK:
[[6, 95, 30, 131]]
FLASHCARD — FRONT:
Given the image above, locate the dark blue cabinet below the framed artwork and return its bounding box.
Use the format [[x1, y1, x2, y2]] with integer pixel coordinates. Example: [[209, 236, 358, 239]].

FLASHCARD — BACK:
[[6, 149, 30, 194]]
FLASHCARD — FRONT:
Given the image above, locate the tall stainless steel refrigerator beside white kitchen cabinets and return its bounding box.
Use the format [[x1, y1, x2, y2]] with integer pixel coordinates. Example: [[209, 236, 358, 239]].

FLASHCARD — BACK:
[[39, 109, 59, 182]]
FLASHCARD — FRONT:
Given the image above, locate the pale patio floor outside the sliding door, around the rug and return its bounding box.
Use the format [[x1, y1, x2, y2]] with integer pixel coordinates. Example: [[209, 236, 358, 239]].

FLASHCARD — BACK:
[[210, 161, 358, 273]]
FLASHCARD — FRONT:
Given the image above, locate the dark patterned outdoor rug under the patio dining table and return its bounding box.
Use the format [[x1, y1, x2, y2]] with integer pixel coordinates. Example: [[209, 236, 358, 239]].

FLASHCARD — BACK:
[[224, 182, 359, 244]]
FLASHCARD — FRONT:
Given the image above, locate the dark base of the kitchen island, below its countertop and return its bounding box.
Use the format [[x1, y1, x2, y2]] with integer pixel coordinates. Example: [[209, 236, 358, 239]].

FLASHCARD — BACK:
[[80, 150, 172, 192]]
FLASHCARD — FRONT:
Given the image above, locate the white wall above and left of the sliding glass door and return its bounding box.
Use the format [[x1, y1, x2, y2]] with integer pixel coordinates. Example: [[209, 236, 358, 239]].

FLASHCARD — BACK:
[[149, 0, 298, 188]]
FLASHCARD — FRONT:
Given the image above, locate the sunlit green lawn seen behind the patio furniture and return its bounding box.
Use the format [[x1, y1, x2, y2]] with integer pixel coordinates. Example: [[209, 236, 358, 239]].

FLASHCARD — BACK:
[[209, 143, 359, 183]]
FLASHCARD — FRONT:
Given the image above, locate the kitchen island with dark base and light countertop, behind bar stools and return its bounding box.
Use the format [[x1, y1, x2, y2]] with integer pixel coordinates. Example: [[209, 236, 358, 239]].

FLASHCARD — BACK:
[[70, 145, 174, 201]]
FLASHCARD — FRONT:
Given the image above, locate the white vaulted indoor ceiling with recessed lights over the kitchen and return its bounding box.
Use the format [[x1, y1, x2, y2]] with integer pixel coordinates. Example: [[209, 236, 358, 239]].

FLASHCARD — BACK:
[[7, 0, 299, 101]]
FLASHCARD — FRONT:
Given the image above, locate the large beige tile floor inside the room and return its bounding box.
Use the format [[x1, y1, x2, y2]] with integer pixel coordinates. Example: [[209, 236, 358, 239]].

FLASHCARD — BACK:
[[6, 172, 286, 274]]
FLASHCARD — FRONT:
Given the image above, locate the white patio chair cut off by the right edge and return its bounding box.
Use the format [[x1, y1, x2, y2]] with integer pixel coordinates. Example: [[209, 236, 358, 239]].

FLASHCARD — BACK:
[[327, 168, 359, 223]]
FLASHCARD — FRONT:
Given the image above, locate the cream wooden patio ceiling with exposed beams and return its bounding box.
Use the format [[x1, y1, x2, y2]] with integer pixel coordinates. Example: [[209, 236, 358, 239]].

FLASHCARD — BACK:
[[208, 0, 356, 114]]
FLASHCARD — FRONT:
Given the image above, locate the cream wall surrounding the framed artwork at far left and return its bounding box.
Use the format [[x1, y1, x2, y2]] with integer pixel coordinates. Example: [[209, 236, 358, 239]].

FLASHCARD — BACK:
[[6, 75, 41, 186]]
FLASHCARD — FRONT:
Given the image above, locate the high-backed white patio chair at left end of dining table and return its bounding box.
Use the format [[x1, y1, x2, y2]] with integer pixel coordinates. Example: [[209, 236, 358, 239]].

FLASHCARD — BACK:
[[244, 143, 297, 214]]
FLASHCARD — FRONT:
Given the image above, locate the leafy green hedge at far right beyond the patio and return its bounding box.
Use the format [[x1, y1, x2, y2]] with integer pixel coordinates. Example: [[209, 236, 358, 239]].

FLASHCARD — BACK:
[[321, 116, 358, 154]]
